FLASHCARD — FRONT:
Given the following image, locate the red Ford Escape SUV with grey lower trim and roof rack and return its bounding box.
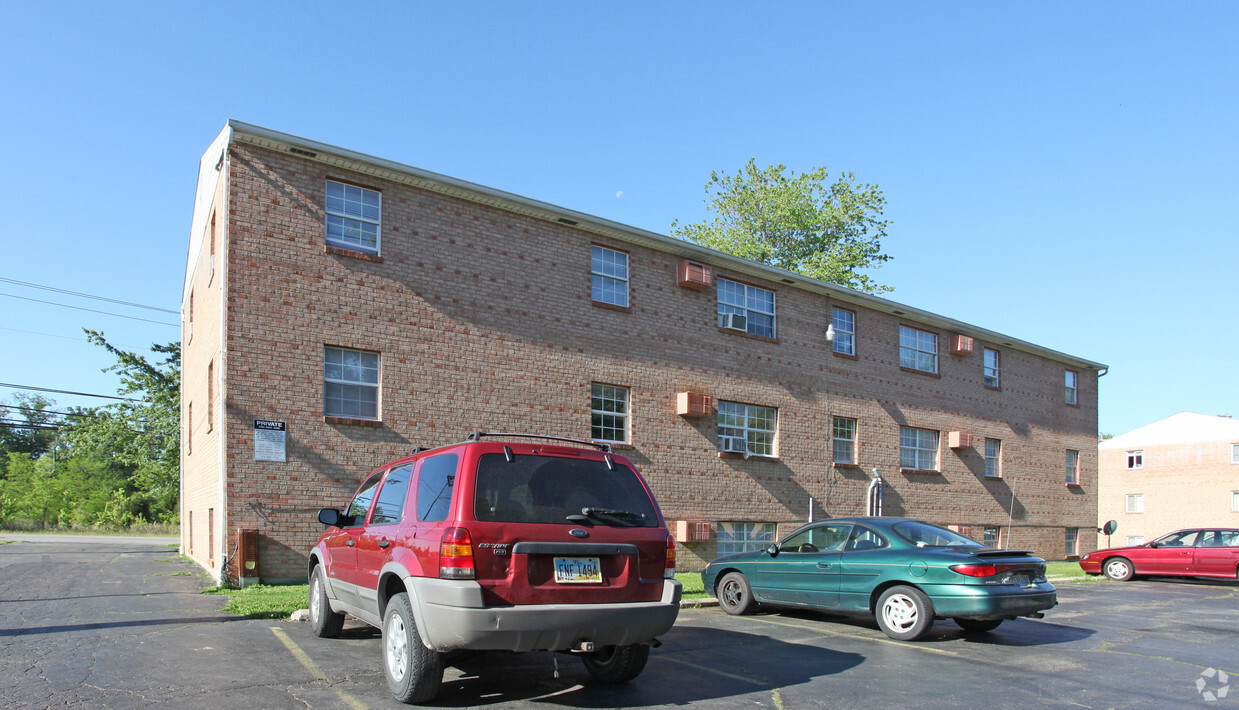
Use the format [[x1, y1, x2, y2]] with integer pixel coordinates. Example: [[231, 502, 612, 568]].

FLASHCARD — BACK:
[[310, 431, 680, 703]]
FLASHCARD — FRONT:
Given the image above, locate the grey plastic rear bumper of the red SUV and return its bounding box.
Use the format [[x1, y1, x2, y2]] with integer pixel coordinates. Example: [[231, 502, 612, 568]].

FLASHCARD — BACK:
[[404, 577, 681, 652]]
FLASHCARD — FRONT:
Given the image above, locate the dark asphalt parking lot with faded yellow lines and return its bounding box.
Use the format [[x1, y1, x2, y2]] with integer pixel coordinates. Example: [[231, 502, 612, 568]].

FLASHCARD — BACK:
[[0, 534, 1239, 709]]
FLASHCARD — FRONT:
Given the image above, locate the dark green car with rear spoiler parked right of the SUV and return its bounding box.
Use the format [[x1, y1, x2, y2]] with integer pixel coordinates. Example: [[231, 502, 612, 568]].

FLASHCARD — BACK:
[[701, 518, 1058, 641]]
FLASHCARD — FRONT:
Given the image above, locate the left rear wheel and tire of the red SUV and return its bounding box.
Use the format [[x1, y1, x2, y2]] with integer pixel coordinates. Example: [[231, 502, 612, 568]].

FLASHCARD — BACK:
[[383, 592, 444, 703]]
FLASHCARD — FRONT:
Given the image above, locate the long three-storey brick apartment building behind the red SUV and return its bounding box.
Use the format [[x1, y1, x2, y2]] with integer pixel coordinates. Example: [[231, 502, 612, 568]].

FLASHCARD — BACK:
[[181, 121, 1105, 582]]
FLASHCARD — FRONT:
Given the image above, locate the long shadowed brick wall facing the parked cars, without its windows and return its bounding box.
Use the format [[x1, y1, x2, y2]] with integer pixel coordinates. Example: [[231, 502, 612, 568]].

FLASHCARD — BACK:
[[203, 144, 1097, 579]]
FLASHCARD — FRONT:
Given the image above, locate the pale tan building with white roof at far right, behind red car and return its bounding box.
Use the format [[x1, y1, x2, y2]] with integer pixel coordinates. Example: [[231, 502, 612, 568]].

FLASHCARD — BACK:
[[1097, 411, 1239, 545]]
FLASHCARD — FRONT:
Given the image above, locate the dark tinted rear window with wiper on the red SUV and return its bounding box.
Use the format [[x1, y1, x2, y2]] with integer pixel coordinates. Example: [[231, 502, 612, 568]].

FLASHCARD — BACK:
[[473, 454, 658, 528]]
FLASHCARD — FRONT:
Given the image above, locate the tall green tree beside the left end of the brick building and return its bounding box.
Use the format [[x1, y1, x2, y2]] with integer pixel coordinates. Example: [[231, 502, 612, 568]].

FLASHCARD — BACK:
[[67, 330, 181, 522]]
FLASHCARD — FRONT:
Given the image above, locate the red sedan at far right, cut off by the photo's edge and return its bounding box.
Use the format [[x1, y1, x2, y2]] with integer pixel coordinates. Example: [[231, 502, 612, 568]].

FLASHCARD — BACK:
[[1080, 528, 1239, 582]]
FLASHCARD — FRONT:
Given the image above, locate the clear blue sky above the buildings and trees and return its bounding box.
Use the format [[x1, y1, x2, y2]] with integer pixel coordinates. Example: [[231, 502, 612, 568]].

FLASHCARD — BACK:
[[0, 1, 1239, 434]]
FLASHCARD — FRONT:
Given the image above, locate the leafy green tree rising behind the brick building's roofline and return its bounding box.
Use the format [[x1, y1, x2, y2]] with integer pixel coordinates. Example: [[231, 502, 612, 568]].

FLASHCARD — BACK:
[[672, 159, 895, 294]]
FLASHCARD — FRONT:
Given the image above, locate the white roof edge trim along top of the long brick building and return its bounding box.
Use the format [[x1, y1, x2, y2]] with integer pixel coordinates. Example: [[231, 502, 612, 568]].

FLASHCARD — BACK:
[[220, 120, 1109, 374]]
